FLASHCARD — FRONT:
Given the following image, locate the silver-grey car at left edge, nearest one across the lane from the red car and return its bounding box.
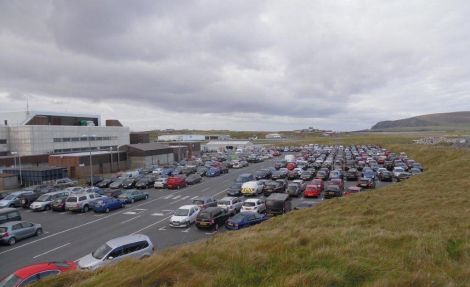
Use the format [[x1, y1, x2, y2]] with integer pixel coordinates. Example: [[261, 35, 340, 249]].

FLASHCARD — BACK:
[[0, 221, 42, 245]]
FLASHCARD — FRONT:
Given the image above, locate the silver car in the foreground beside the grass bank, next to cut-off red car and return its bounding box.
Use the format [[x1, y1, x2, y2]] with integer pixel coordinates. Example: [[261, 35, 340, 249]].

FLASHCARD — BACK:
[[78, 234, 154, 270]]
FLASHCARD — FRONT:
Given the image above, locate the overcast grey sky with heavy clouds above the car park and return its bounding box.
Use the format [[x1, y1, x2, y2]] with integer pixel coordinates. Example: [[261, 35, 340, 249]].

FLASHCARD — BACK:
[[0, 0, 470, 130]]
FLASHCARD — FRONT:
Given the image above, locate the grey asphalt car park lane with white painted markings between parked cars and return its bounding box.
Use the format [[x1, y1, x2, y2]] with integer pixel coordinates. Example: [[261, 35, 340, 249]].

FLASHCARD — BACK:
[[0, 160, 392, 278]]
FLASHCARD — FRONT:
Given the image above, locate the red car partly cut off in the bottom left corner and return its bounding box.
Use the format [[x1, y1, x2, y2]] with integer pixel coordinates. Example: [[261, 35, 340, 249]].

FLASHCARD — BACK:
[[0, 261, 77, 287]]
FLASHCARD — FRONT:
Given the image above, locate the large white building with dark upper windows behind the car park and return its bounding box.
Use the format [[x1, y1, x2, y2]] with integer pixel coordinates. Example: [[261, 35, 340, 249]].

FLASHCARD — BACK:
[[0, 111, 129, 156]]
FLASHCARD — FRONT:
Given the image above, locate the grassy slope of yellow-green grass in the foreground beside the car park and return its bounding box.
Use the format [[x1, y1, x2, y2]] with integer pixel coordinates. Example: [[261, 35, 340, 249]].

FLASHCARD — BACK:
[[37, 135, 470, 287]]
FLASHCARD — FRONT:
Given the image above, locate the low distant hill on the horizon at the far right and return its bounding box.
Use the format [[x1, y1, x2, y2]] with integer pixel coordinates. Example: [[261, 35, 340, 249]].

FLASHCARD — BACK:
[[371, 112, 470, 131]]
